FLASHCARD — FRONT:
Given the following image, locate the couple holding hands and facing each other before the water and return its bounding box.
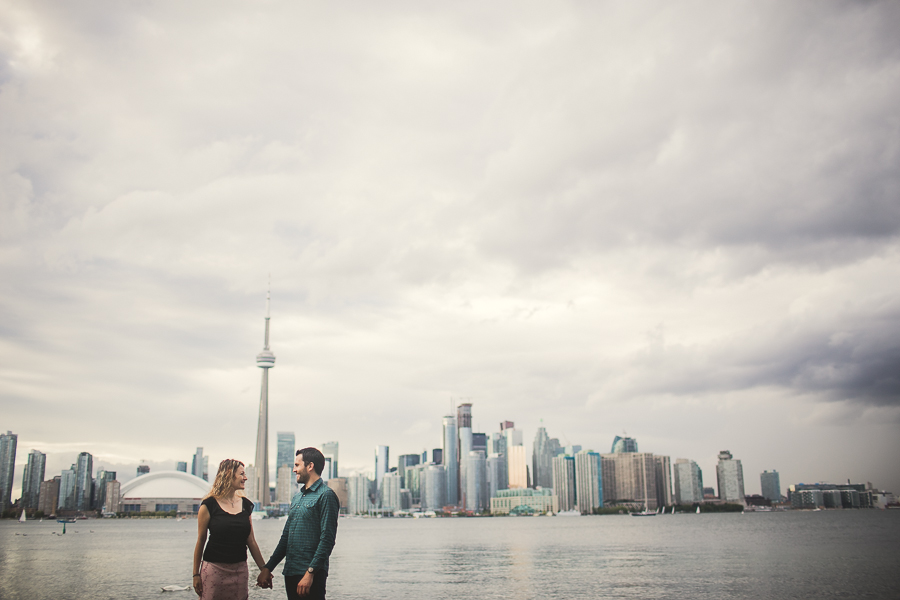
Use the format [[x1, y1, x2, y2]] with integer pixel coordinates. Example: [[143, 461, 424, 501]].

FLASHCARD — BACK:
[[193, 448, 340, 600]]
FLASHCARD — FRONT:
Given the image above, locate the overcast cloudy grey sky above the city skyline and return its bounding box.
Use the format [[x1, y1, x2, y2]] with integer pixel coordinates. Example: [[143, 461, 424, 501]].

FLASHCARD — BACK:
[[0, 1, 900, 498]]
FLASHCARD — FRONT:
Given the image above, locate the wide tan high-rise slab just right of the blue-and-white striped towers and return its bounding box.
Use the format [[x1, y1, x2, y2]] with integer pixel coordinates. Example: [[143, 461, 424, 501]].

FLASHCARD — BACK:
[[604, 452, 665, 510]]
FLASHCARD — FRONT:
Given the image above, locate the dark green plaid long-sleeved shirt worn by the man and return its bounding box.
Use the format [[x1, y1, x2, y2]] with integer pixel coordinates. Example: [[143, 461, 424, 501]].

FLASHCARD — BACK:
[[266, 479, 341, 575]]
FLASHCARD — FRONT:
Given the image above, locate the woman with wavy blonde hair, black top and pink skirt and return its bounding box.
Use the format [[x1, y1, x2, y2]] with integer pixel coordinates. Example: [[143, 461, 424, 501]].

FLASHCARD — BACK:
[[193, 458, 266, 600]]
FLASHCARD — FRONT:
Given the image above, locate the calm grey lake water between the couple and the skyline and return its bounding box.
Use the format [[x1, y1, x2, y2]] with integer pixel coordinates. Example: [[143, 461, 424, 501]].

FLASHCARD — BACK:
[[0, 510, 900, 600]]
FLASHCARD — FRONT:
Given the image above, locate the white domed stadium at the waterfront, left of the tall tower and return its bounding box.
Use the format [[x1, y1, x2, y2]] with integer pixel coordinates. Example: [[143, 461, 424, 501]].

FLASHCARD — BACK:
[[119, 471, 209, 514]]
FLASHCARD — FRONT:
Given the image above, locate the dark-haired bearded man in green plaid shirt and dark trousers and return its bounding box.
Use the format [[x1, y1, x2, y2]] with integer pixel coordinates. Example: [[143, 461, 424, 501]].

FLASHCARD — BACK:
[[256, 448, 340, 600]]
